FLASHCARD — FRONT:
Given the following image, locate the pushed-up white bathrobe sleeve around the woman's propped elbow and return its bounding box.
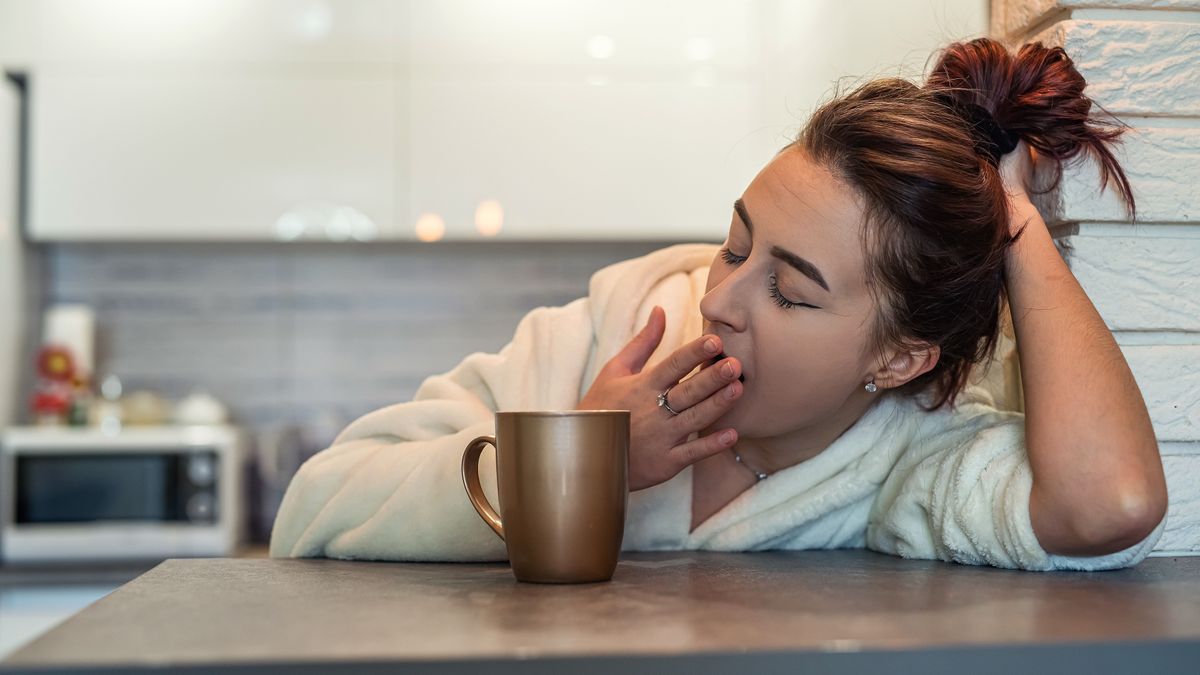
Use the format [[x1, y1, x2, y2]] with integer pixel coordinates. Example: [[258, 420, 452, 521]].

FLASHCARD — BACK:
[[866, 391, 1165, 571]]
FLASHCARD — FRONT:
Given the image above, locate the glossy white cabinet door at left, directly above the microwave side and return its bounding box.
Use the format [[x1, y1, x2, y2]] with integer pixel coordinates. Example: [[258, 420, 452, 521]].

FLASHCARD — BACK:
[[29, 71, 396, 240]]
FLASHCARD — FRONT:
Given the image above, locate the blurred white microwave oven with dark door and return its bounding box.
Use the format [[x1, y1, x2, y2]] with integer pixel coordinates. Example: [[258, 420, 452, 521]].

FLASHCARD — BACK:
[[0, 425, 247, 563]]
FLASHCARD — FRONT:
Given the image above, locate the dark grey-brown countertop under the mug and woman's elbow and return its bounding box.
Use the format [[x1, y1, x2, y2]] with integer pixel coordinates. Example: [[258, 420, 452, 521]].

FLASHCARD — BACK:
[[0, 550, 1200, 675]]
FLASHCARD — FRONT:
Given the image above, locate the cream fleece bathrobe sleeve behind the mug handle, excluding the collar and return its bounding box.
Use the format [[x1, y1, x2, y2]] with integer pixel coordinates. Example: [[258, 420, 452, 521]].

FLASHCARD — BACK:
[[270, 298, 594, 562]]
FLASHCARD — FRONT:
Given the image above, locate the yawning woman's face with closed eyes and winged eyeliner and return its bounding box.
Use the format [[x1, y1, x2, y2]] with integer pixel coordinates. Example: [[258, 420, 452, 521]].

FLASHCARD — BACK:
[[700, 147, 878, 437]]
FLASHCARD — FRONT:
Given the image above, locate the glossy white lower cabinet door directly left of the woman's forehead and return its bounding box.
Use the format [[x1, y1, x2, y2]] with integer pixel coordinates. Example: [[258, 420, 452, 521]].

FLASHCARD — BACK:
[[408, 80, 763, 241]]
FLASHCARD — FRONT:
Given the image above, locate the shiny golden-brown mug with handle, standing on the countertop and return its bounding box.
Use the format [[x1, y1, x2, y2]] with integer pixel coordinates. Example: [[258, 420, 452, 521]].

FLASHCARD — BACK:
[[462, 411, 629, 584]]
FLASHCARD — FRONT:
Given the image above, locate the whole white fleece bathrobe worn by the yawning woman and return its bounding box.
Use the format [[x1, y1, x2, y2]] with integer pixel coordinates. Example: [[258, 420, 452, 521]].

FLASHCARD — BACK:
[[271, 244, 1163, 569]]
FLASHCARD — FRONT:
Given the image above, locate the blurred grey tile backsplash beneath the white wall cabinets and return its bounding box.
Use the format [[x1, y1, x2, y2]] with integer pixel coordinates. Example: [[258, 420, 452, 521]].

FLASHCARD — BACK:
[[32, 241, 691, 538]]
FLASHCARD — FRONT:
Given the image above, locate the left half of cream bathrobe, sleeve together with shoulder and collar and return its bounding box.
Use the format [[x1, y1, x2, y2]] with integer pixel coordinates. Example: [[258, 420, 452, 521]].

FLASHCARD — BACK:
[[270, 244, 716, 562]]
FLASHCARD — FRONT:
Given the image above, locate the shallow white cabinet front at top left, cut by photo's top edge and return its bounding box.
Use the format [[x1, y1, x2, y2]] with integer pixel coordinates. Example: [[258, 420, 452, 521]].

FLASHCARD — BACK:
[[8, 0, 398, 68]]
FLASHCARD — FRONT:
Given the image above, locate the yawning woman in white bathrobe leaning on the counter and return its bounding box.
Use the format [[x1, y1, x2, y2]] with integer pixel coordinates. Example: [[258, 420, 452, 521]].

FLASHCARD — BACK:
[[271, 40, 1166, 569]]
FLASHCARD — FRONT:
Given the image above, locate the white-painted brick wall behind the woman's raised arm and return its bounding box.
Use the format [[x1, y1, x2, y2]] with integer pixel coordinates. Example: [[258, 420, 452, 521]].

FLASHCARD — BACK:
[[991, 0, 1200, 555]]
